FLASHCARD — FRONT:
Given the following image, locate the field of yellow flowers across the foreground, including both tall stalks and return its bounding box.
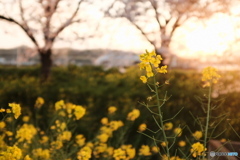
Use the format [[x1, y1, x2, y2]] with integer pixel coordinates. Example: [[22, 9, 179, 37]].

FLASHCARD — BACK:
[[0, 51, 239, 160]]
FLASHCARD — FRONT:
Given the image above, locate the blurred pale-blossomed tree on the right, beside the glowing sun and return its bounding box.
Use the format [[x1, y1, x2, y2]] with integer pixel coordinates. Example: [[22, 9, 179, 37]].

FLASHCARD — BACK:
[[106, 0, 231, 63]]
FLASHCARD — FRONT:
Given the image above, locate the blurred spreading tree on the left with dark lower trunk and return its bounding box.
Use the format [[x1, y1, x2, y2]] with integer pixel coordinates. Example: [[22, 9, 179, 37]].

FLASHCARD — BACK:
[[0, 0, 85, 82]]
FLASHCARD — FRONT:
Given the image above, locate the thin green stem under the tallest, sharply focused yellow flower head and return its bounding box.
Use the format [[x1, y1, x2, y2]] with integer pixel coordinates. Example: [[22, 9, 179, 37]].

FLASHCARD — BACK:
[[153, 75, 170, 160]]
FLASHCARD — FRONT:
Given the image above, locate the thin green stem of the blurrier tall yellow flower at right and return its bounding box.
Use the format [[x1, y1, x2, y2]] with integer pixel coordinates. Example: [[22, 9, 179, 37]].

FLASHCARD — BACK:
[[202, 83, 212, 159]]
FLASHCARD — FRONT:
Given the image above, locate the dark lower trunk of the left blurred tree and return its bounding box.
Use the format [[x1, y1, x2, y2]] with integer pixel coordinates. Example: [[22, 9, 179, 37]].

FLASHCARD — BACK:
[[39, 49, 52, 83]]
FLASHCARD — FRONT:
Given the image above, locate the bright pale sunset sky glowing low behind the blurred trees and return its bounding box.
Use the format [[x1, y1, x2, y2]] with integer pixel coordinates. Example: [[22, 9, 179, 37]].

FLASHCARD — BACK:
[[0, 0, 239, 58]]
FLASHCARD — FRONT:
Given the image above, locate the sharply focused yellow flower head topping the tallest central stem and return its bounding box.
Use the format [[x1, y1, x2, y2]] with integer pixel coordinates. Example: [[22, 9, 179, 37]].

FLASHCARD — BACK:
[[139, 51, 167, 83]]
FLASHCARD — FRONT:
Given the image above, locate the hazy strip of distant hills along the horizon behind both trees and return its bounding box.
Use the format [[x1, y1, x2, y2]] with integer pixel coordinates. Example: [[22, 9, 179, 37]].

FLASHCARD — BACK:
[[0, 46, 240, 70]]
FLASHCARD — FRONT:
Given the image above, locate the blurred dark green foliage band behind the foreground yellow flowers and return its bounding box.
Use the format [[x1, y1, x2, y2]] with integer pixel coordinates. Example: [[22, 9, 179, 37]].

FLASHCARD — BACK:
[[0, 66, 240, 141]]
